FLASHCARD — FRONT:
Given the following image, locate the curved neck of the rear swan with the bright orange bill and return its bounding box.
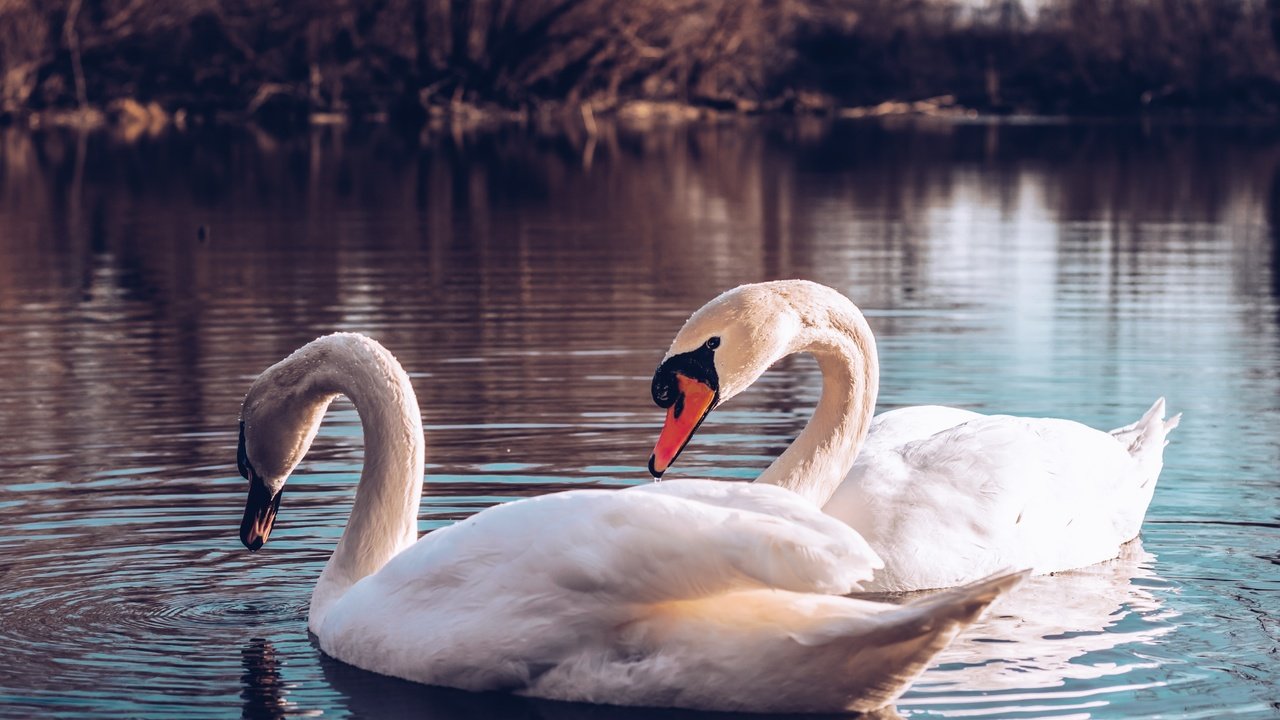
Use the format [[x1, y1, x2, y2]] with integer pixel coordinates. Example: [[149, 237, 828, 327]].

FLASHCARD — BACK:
[[756, 309, 879, 507]]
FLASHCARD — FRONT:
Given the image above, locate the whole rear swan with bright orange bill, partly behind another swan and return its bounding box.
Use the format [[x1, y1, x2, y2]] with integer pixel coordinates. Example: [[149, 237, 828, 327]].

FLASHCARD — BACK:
[[649, 281, 1180, 592]]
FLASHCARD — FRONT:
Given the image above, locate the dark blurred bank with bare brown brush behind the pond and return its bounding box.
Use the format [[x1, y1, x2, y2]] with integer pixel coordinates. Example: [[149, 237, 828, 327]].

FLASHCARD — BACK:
[[0, 0, 1280, 128]]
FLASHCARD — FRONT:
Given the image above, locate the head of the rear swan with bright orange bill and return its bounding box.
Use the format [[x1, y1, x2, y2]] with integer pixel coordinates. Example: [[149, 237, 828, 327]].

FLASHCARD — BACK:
[[649, 281, 808, 478]]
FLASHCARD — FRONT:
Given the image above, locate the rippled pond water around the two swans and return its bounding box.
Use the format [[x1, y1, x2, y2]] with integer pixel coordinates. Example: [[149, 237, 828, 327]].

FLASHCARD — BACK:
[[0, 122, 1280, 719]]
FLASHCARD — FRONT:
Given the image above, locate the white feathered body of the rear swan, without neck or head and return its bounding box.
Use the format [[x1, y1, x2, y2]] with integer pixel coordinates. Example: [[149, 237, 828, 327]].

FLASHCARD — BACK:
[[823, 398, 1178, 591]]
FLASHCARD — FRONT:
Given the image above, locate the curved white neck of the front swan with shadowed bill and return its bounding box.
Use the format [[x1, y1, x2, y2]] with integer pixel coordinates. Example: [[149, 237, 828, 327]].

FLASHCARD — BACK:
[[300, 341, 425, 632]]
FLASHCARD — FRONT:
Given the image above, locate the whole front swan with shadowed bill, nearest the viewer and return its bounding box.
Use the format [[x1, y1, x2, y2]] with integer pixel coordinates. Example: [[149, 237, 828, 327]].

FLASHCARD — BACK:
[[238, 333, 1025, 712]]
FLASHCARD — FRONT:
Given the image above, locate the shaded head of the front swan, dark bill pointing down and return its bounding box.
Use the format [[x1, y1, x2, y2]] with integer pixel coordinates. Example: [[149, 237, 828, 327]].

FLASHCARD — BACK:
[[236, 343, 334, 552]]
